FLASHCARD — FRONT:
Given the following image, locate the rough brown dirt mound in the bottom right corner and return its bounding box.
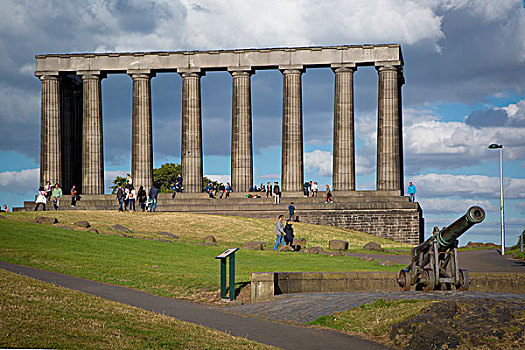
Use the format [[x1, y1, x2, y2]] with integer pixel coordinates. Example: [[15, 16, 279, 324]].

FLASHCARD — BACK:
[[390, 298, 525, 349]]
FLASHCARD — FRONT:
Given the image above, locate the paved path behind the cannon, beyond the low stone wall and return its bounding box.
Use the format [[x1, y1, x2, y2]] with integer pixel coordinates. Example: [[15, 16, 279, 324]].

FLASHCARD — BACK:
[[348, 249, 525, 273]]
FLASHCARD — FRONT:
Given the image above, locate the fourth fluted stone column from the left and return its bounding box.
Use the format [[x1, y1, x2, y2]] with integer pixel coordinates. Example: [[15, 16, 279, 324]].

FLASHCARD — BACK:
[[180, 71, 203, 193]]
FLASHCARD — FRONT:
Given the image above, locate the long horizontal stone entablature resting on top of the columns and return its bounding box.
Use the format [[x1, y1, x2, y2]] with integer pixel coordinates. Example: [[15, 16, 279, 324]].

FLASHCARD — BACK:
[[35, 44, 403, 75]]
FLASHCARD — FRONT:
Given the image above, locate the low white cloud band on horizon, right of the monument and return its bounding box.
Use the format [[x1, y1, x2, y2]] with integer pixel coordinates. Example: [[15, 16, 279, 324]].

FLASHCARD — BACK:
[[407, 174, 525, 199]]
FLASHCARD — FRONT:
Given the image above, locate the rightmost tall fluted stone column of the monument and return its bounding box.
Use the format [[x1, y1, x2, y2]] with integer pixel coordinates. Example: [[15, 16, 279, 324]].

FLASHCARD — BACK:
[[377, 66, 403, 191]]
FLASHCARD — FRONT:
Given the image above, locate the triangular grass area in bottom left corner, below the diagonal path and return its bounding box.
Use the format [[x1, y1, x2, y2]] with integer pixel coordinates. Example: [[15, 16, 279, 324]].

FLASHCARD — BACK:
[[0, 269, 275, 349]]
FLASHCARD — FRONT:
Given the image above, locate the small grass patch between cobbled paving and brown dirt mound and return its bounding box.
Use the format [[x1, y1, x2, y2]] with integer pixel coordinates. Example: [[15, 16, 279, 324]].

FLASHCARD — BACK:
[[309, 299, 432, 337]]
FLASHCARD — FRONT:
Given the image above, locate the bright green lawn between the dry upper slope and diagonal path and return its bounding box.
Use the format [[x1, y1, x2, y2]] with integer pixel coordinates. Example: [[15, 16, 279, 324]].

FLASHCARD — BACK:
[[0, 216, 399, 301]]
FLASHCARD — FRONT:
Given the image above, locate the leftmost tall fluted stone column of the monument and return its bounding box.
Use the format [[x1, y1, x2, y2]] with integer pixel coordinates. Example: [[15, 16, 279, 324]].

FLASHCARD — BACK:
[[40, 75, 62, 184]]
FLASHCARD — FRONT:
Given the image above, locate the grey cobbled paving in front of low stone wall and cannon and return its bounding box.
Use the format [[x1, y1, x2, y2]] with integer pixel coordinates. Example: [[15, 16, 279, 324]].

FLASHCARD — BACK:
[[226, 291, 525, 323]]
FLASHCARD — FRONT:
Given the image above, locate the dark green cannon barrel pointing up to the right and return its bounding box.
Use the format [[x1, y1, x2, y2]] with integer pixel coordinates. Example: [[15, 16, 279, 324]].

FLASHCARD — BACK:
[[411, 206, 485, 260]]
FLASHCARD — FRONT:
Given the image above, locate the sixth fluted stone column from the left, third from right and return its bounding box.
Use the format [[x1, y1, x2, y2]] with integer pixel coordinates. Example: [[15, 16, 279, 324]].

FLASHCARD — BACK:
[[281, 69, 304, 192]]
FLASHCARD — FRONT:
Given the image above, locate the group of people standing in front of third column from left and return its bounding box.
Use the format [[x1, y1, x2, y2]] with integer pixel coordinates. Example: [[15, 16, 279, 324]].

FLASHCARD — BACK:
[[116, 174, 159, 213]]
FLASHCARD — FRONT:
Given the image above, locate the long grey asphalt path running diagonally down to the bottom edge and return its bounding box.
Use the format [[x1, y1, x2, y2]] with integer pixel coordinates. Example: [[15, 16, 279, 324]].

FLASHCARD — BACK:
[[0, 261, 386, 350]]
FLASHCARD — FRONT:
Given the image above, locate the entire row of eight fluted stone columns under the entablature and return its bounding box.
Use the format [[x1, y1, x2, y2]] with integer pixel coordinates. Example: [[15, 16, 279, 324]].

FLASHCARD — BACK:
[[40, 66, 403, 194]]
